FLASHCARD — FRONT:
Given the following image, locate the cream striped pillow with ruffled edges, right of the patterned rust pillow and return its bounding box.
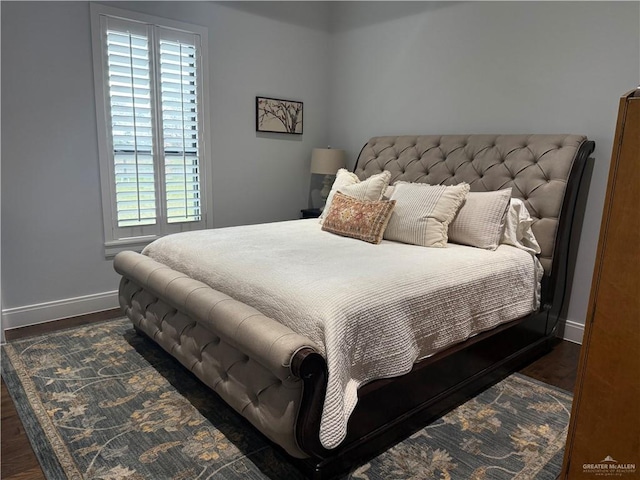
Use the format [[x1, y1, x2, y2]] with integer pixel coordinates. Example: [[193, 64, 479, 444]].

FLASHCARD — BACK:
[[384, 182, 469, 247]]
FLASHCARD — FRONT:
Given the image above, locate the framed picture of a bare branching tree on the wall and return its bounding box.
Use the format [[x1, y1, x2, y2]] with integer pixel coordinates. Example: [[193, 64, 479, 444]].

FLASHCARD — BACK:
[[256, 97, 303, 135]]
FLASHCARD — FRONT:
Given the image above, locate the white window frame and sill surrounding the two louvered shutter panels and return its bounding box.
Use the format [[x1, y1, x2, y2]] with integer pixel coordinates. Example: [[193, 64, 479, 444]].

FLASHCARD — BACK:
[[90, 3, 213, 258]]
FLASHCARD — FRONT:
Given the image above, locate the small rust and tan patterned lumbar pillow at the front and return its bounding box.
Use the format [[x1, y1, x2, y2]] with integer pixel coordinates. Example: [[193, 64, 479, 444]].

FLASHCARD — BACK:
[[322, 192, 396, 244]]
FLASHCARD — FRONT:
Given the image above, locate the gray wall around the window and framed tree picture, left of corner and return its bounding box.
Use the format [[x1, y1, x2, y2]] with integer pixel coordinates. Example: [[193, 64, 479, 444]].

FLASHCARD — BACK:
[[1, 1, 330, 329]]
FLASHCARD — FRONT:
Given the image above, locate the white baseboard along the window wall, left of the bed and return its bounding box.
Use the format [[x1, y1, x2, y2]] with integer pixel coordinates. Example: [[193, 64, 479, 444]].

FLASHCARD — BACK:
[[1, 290, 119, 339]]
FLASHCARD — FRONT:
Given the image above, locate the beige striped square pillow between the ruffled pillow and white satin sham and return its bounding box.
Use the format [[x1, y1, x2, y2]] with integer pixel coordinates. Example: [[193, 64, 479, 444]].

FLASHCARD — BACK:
[[449, 187, 511, 250]]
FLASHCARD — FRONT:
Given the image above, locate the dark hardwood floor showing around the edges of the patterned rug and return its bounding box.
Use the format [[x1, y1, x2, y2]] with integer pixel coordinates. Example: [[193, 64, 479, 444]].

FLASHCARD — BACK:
[[0, 311, 580, 480]]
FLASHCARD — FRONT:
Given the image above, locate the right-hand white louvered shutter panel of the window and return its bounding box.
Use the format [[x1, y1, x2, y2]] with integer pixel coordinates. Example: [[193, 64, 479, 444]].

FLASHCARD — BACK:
[[158, 28, 201, 223]]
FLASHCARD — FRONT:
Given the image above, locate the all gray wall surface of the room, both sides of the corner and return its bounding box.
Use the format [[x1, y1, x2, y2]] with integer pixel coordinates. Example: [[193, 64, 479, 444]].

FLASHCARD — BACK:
[[1, 2, 640, 342]]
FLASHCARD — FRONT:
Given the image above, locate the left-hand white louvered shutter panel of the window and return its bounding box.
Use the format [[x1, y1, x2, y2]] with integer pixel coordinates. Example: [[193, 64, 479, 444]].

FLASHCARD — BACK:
[[106, 20, 157, 227]]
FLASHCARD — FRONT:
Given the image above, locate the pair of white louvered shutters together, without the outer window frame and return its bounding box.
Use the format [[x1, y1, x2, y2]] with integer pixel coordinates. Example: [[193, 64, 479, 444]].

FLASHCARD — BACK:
[[105, 18, 202, 233]]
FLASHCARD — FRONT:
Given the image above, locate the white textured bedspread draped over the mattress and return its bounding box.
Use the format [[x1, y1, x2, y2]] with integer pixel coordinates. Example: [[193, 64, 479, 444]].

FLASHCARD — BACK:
[[143, 219, 542, 448]]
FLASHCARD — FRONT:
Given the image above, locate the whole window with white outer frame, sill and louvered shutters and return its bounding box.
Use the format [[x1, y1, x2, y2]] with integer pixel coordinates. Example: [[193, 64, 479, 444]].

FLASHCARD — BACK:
[[91, 4, 211, 256]]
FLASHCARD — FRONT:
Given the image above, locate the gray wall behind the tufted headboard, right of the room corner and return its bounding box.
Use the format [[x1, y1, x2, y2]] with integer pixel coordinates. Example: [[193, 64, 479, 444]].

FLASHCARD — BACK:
[[329, 2, 640, 341]]
